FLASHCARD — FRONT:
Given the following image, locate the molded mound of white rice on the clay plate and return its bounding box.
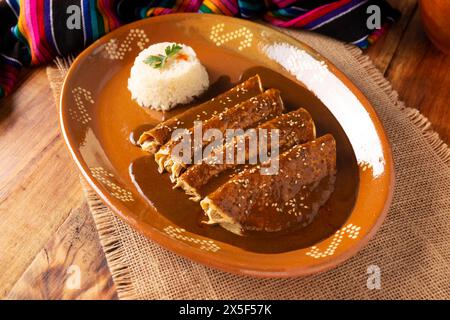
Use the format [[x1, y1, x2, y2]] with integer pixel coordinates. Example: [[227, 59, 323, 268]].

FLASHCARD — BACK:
[[128, 42, 209, 110]]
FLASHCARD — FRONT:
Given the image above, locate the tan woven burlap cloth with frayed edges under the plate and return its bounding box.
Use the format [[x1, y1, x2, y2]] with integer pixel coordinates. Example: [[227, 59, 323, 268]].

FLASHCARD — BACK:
[[48, 32, 450, 299]]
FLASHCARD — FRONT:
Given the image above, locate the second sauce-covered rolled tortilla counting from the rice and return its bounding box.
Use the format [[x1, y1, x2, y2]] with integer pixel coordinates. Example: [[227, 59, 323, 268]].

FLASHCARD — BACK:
[[155, 89, 284, 182]]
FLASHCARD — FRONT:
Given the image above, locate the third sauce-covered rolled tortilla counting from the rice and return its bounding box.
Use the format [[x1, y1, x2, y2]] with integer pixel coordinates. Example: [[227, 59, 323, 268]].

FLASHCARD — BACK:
[[175, 108, 316, 201]]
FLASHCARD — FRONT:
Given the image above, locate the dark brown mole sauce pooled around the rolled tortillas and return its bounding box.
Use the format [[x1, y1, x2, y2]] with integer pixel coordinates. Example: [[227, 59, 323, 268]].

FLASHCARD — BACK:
[[129, 67, 359, 253]]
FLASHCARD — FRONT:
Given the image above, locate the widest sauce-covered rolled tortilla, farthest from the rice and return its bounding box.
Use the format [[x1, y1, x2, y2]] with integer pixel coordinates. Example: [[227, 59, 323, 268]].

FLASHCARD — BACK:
[[200, 134, 336, 235]]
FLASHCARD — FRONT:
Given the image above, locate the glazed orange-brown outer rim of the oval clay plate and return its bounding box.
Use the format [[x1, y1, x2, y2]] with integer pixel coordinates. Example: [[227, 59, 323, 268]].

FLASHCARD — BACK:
[[60, 13, 395, 278]]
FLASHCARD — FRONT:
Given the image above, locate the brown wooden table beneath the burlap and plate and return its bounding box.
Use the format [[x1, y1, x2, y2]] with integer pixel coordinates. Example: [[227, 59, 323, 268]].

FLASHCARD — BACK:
[[0, 0, 450, 299]]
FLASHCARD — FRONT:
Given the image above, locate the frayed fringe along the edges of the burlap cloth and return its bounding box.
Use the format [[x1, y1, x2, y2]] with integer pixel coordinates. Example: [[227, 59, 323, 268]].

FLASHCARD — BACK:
[[47, 39, 450, 299]]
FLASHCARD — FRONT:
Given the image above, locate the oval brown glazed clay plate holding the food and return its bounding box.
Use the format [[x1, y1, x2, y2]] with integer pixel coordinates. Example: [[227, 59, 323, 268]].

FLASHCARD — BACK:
[[61, 14, 394, 277]]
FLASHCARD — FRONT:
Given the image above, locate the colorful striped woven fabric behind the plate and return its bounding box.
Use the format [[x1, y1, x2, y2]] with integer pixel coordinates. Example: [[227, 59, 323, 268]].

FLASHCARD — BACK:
[[0, 0, 400, 97]]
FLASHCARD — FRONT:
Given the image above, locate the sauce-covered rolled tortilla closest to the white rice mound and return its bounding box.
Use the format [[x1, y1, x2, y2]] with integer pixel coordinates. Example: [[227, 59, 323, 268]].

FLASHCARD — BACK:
[[138, 75, 263, 154]]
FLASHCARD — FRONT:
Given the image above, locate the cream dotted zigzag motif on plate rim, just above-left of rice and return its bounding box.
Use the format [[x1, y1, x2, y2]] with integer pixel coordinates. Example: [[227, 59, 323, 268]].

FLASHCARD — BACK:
[[105, 29, 149, 60]]
